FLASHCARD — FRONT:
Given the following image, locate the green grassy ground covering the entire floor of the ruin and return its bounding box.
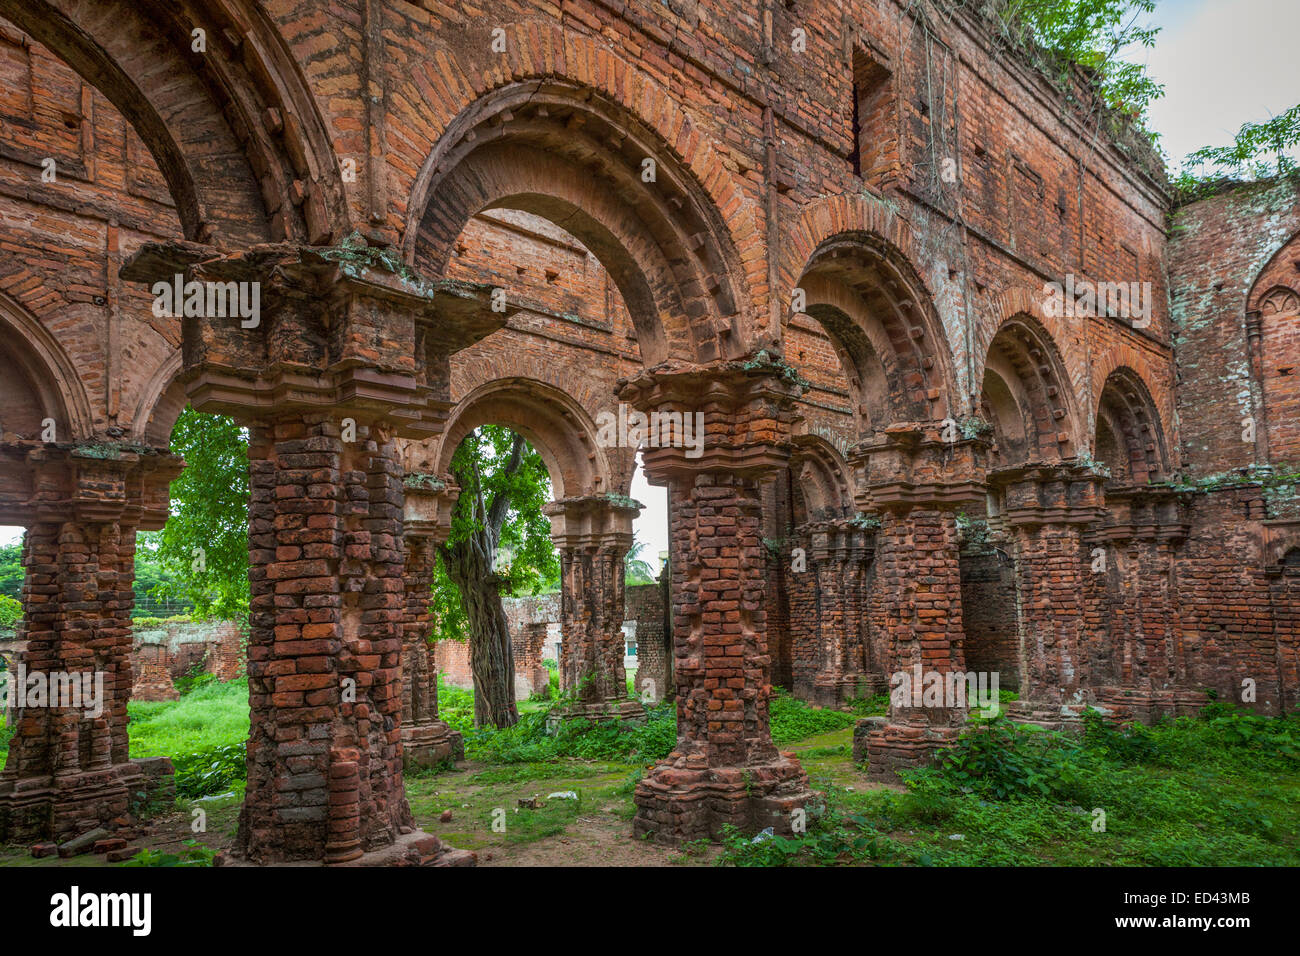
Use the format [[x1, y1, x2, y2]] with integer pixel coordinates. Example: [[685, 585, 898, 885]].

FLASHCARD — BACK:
[[0, 682, 1300, 866]]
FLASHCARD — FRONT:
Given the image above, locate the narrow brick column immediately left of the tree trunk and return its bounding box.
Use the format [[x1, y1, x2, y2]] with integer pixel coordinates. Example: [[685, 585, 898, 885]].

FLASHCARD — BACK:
[[402, 473, 465, 767]]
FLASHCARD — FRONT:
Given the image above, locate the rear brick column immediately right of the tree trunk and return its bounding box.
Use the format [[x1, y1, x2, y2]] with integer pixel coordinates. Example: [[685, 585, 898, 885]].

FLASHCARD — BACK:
[[542, 496, 645, 719]]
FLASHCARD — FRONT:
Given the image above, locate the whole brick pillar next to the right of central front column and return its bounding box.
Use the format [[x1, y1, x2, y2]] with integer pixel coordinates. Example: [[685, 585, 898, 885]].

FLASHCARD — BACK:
[[850, 423, 987, 779]]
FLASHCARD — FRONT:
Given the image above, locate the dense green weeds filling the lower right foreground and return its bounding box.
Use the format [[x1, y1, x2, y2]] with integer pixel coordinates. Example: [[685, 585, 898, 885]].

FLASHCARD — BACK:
[[718, 704, 1300, 866]]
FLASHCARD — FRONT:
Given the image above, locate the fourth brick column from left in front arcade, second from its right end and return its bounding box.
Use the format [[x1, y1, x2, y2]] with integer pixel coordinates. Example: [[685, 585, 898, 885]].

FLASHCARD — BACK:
[[989, 460, 1105, 722]]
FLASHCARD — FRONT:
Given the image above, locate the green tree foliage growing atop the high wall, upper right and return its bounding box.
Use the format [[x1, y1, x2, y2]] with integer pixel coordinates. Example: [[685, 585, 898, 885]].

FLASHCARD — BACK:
[[991, 0, 1165, 132]]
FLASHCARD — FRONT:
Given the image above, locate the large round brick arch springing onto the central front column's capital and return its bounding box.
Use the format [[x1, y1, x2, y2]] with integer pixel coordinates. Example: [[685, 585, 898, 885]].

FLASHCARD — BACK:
[[390, 21, 767, 364]]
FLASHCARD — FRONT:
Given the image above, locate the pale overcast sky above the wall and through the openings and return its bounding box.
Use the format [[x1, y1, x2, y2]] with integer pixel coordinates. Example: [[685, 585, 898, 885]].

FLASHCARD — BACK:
[[0, 0, 1300, 567]]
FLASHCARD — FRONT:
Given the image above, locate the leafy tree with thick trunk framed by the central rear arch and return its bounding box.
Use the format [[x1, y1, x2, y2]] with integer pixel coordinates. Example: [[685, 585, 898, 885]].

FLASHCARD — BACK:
[[433, 425, 559, 727]]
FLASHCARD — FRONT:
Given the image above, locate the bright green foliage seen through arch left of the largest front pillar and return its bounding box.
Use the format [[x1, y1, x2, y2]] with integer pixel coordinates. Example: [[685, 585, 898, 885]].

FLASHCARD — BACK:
[[150, 407, 248, 619]]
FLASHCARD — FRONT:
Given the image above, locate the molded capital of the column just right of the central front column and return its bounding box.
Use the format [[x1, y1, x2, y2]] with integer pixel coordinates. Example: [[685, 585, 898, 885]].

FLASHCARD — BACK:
[[848, 421, 991, 511]]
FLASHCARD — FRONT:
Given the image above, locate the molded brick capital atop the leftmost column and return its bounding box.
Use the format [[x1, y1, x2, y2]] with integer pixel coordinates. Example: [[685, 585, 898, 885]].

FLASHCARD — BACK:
[[0, 441, 185, 531]]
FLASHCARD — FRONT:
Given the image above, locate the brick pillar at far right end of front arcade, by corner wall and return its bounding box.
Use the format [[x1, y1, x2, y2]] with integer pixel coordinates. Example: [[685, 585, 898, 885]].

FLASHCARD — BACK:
[[1087, 488, 1205, 721]]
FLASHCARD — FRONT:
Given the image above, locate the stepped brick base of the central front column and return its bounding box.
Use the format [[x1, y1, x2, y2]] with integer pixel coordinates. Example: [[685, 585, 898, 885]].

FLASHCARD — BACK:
[[632, 753, 823, 847]]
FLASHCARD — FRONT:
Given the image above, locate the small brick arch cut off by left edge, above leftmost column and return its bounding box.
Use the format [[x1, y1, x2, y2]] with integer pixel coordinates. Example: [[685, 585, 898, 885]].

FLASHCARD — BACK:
[[0, 291, 95, 442]]
